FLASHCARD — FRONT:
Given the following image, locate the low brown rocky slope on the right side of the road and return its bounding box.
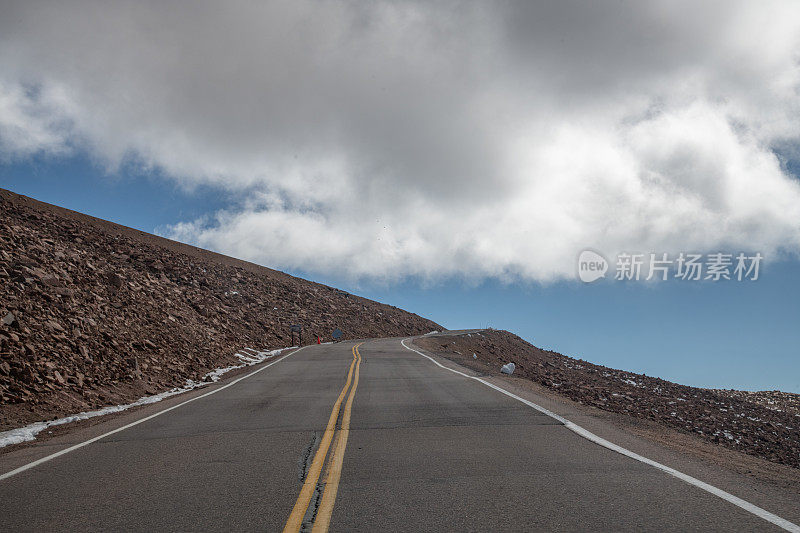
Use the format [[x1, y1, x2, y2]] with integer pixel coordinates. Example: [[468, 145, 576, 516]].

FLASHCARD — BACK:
[[415, 330, 800, 468]]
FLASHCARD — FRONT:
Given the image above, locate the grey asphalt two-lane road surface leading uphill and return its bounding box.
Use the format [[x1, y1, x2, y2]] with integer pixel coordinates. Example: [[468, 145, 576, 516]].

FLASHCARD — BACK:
[[0, 339, 796, 531]]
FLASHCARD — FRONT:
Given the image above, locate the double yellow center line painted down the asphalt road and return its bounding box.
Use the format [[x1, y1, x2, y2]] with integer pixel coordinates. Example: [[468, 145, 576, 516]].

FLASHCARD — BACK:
[[283, 343, 363, 533]]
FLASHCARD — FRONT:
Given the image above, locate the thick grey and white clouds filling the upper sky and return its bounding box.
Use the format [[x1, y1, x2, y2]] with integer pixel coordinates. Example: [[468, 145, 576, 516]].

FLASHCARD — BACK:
[[0, 0, 800, 387]]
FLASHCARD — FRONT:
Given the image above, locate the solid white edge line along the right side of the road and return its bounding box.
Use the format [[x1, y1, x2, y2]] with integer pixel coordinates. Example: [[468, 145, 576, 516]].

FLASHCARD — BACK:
[[400, 337, 800, 533]]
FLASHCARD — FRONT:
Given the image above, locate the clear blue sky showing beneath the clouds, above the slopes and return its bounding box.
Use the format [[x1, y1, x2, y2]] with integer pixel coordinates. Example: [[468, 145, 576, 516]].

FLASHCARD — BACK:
[[0, 157, 800, 392]]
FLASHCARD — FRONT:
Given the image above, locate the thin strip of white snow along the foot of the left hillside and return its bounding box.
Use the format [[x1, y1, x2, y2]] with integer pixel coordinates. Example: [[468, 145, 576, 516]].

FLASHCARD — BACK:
[[0, 346, 295, 448]]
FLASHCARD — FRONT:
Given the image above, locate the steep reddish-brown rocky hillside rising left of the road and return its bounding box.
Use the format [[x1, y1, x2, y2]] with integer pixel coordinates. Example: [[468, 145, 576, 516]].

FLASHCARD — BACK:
[[0, 189, 441, 430]]
